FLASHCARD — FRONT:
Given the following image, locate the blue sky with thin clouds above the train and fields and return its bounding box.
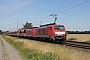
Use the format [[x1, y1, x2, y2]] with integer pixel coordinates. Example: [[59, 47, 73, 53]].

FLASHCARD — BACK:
[[0, 0, 90, 31]]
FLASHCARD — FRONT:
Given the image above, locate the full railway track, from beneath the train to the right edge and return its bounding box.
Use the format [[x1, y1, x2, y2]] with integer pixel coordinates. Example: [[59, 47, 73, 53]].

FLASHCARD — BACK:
[[4, 35, 90, 50]]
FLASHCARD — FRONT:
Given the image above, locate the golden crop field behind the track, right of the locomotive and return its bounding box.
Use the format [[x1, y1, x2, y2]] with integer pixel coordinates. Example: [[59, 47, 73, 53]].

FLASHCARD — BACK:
[[67, 34, 90, 43]]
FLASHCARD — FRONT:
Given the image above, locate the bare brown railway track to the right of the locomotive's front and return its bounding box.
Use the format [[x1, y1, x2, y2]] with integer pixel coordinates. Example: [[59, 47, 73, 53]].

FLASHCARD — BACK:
[[64, 41, 90, 49]]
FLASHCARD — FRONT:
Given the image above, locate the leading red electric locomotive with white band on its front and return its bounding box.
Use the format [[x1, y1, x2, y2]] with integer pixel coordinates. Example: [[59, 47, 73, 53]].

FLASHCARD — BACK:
[[37, 23, 66, 41]]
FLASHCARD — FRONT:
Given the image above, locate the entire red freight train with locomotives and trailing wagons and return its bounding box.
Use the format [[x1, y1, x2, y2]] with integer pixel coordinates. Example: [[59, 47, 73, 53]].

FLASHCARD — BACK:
[[7, 23, 67, 42]]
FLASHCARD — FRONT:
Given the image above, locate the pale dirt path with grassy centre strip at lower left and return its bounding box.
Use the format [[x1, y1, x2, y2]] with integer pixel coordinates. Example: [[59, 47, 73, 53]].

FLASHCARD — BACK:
[[0, 36, 24, 60]]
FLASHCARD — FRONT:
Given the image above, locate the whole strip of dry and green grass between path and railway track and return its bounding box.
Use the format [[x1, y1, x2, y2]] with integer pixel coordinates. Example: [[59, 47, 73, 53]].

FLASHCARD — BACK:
[[4, 36, 90, 60]]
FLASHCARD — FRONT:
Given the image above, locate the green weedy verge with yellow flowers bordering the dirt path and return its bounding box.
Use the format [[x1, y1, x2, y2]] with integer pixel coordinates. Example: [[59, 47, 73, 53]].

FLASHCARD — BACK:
[[4, 36, 55, 60]]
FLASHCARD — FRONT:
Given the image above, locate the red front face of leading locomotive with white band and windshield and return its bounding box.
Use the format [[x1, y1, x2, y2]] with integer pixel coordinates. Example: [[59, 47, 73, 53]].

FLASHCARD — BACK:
[[54, 25, 66, 41]]
